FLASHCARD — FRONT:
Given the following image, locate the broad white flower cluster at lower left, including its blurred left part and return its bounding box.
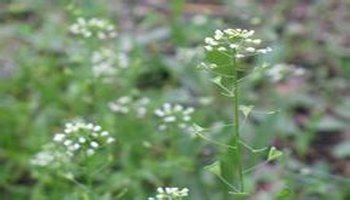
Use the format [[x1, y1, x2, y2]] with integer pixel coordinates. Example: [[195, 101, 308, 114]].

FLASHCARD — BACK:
[[31, 121, 115, 167]]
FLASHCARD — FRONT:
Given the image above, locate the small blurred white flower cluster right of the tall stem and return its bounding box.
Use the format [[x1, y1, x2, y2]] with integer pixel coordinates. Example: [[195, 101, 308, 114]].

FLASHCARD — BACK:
[[265, 63, 305, 82]]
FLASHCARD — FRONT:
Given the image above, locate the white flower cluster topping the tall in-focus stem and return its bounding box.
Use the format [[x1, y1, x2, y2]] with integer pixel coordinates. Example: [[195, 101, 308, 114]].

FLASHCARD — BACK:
[[204, 29, 272, 58]]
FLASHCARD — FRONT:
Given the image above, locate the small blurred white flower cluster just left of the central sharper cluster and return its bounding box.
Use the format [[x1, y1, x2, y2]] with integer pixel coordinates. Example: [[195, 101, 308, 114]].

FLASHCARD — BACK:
[[108, 96, 150, 118]]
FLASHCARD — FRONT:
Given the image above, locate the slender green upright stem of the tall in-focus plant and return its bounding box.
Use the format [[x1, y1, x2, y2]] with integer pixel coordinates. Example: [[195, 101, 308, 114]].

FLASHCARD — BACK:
[[232, 54, 244, 192]]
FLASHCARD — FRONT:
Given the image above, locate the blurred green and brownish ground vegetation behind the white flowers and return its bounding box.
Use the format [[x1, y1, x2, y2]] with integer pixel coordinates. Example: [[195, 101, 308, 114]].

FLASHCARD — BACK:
[[0, 0, 350, 200]]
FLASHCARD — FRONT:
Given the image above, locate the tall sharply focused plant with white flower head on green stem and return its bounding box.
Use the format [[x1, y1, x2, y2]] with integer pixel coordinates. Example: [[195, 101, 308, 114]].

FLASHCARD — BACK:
[[199, 29, 271, 198]]
